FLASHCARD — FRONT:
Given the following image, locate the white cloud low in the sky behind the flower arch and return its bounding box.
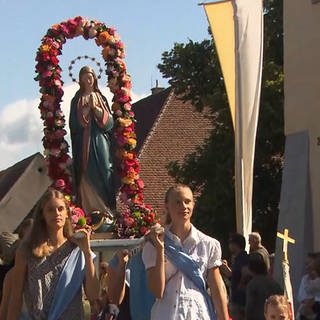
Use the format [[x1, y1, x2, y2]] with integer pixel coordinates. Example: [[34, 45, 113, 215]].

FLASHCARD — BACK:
[[0, 83, 147, 171]]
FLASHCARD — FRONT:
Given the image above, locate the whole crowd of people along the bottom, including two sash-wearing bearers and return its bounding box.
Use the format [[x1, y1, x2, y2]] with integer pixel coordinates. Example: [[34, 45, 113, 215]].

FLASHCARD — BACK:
[[0, 184, 320, 320]]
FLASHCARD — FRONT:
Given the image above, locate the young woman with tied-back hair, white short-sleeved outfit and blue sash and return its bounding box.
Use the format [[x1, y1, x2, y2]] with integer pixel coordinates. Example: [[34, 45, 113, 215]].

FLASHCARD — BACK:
[[142, 184, 228, 320]]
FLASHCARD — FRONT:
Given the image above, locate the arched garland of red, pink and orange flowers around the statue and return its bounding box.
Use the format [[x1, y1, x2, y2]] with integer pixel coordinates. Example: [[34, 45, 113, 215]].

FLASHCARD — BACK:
[[35, 17, 157, 238]]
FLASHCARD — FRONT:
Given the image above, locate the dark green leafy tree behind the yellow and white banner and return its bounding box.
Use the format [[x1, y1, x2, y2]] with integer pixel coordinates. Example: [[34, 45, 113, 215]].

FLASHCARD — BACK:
[[158, 0, 284, 249]]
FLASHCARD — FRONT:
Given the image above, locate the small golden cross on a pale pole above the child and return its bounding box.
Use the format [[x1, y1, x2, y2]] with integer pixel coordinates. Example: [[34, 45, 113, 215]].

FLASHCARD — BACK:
[[277, 229, 296, 320]]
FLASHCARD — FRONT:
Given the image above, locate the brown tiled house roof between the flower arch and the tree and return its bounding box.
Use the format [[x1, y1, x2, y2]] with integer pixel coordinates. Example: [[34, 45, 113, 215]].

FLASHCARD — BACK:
[[133, 88, 212, 212]]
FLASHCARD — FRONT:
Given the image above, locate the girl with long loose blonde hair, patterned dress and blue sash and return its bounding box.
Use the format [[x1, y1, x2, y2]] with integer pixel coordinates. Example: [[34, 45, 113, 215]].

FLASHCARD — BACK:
[[7, 190, 99, 320]]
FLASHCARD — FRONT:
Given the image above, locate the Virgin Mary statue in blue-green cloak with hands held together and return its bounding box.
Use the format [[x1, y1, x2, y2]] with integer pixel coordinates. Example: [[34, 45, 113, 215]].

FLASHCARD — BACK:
[[69, 66, 116, 214]]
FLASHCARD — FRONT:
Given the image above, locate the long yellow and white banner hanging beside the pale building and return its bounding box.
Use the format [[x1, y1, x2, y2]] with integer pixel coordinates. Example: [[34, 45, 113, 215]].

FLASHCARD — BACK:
[[203, 0, 263, 237]]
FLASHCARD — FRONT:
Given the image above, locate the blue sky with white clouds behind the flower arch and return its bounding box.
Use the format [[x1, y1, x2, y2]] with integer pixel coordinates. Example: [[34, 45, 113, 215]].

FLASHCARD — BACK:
[[0, 0, 208, 170]]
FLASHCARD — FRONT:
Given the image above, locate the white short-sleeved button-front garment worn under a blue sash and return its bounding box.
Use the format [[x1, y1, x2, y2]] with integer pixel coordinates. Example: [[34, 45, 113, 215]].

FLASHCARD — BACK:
[[142, 226, 221, 320]]
